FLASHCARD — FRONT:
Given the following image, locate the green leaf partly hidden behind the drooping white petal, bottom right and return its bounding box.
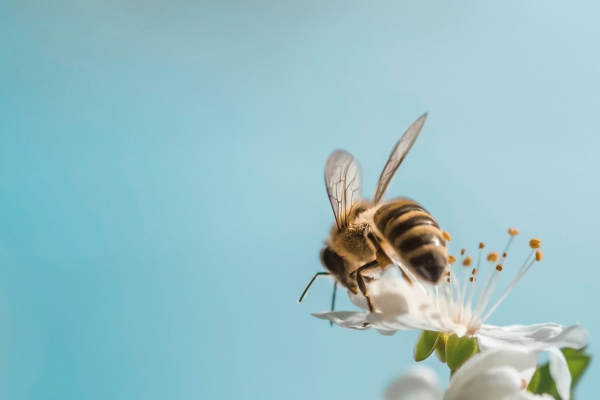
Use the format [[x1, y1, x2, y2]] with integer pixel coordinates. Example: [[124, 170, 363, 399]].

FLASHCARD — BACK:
[[527, 348, 592, 400]]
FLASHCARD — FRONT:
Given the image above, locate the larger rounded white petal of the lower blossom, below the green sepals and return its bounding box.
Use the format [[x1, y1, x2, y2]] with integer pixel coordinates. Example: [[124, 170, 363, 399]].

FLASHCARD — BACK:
[[445, 348, 537, 400]]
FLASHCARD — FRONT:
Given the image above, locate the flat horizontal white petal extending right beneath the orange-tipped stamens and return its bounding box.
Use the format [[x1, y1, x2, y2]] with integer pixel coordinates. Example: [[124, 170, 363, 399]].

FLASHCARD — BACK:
[[475, 322, 589, 352]]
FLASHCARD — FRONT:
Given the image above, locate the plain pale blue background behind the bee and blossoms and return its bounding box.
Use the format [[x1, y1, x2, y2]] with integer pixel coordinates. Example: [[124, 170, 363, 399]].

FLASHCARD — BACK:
[[0, 0, 600, 399]]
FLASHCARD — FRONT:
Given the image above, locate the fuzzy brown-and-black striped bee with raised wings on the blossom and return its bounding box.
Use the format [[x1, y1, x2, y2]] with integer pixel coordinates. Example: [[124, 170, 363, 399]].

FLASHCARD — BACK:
[[299, 113, 448, 312]]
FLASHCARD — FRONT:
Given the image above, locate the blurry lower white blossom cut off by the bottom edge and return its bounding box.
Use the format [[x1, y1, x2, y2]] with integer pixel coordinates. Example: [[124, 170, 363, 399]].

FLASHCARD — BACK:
[[384, 348, 554, 400]]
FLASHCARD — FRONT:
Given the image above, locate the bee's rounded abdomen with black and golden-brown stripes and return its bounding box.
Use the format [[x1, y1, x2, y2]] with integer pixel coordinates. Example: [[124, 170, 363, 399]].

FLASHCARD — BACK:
[[373, 199, 448, 283]]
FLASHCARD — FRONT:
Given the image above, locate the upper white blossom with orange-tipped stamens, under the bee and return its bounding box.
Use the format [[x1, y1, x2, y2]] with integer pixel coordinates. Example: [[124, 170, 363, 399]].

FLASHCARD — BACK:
[[313, 231, 589, 400]]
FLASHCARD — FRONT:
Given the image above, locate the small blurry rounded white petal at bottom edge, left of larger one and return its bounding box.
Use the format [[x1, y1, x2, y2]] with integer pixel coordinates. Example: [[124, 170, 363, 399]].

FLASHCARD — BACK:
[[383, 366, 442, 400]]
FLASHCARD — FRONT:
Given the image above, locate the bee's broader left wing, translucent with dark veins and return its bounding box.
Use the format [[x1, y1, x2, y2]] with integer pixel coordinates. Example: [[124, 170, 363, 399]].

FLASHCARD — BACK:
[[325, 150, 360, 229]]
